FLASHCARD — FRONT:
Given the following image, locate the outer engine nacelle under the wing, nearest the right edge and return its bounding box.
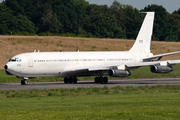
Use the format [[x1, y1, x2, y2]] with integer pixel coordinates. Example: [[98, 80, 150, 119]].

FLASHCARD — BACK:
[[150, 65, 174, 73]]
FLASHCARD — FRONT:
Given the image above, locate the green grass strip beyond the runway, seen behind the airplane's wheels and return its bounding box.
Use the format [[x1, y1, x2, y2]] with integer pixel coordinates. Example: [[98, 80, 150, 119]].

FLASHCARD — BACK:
[[0, 64, 180, 83]]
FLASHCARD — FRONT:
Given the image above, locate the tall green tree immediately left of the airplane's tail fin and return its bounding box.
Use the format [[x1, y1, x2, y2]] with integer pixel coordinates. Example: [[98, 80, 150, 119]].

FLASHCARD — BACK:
[[110, 0, 143, 39]]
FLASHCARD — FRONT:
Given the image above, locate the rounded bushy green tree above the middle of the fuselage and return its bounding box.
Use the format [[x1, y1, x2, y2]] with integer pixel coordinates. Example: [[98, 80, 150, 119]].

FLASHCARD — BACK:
[[84, 14, 125, 38]]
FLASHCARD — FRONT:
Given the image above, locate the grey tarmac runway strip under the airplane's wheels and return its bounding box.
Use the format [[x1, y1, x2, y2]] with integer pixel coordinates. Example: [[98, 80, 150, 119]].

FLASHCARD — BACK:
[[0, 78, 180, 90]]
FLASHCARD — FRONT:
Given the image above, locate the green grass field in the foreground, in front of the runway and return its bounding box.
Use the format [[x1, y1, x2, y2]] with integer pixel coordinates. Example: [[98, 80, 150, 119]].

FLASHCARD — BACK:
[[0, 86, 180, 120]]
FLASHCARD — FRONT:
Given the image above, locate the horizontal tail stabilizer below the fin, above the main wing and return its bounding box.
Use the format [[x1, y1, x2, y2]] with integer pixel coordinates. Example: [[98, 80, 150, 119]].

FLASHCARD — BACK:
[[143, 51, 180, 62]]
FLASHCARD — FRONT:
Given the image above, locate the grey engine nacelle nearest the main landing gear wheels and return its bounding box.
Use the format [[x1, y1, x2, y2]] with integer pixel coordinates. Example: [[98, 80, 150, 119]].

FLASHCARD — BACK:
[[108, 69, 131, 77]]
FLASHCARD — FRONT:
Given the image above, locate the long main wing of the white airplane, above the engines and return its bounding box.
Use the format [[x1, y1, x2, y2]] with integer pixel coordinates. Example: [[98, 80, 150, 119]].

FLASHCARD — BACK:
[[61, 60, 180, 76]]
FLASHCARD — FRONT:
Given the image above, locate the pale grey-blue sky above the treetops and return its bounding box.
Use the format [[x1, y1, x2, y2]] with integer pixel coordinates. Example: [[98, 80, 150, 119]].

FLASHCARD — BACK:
[[0, 0, 180, 13]]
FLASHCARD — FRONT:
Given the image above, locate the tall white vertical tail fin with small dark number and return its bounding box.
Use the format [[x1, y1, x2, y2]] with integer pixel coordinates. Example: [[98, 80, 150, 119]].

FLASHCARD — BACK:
[[129, 12, 155, 53]]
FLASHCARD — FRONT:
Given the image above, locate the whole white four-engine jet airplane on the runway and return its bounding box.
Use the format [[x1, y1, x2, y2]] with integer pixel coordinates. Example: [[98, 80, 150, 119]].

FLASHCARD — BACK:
[[4, 12, 180, 85]]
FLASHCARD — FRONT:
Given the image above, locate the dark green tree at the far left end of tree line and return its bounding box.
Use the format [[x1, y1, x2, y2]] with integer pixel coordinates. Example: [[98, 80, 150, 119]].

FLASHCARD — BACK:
[[0, 4, 35, 34]]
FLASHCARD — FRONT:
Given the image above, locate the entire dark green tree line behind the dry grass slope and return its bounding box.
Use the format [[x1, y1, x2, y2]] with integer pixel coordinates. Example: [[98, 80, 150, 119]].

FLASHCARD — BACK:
[[0, 0, 180, 41]]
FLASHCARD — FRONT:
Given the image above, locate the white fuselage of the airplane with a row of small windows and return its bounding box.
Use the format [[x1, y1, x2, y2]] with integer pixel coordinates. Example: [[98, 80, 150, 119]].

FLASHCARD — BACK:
[[6, 51, 150, 78]]
